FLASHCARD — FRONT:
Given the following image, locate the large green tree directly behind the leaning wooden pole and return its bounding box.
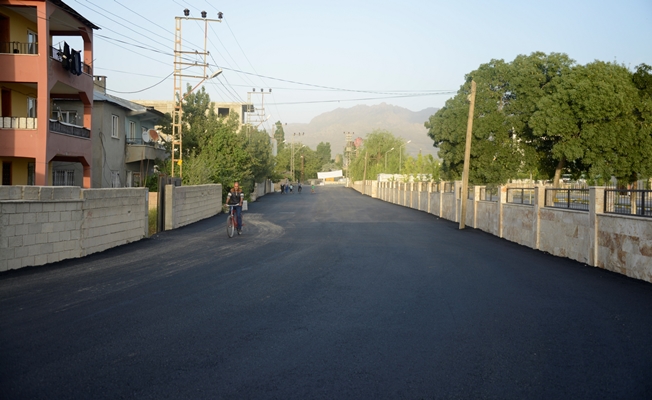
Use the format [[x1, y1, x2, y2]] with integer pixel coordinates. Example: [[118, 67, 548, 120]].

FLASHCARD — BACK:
[[425, 52, 573, 183]]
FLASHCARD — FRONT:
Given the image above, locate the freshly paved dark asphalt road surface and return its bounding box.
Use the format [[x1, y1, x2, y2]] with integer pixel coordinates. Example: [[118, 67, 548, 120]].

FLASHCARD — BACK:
[[0, 187, 652, 399]]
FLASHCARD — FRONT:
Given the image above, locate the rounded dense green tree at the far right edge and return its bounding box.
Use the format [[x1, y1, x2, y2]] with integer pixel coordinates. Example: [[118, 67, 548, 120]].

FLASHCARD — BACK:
[[529, 61, 652, 183]]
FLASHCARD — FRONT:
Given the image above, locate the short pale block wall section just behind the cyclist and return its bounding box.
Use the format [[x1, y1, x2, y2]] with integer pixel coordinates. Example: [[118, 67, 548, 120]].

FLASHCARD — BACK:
[[165, 185, 224, 230]]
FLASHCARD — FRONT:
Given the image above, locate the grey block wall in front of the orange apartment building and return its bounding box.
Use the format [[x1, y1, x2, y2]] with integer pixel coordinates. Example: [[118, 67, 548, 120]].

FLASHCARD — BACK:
[[0, 186, 148, 271]]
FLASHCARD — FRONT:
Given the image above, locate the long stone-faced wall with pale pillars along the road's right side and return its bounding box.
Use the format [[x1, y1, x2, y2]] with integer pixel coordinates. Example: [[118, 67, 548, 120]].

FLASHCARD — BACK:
[[356, 182, 652, 282]]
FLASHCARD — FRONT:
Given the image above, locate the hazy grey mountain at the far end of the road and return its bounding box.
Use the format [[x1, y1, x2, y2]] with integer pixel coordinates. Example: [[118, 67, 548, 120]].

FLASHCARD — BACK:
[[284, 103, 438, 157]]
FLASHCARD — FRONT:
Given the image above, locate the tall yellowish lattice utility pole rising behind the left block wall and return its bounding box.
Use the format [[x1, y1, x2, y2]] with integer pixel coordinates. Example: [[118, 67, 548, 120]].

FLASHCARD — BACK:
[[170, 8, 223, 177]]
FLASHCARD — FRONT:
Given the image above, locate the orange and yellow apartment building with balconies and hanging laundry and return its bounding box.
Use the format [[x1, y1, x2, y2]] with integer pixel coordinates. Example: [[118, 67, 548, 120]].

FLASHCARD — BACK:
[[0, 0, 99, 188]]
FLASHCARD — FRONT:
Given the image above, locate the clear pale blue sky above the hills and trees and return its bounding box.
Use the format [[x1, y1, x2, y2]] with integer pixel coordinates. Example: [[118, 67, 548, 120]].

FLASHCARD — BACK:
[[58, 0, 652, 134]]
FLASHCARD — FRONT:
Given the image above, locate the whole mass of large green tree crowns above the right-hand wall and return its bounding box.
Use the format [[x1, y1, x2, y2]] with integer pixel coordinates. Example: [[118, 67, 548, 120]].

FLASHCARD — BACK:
[[425, 52, 652, 183]]
